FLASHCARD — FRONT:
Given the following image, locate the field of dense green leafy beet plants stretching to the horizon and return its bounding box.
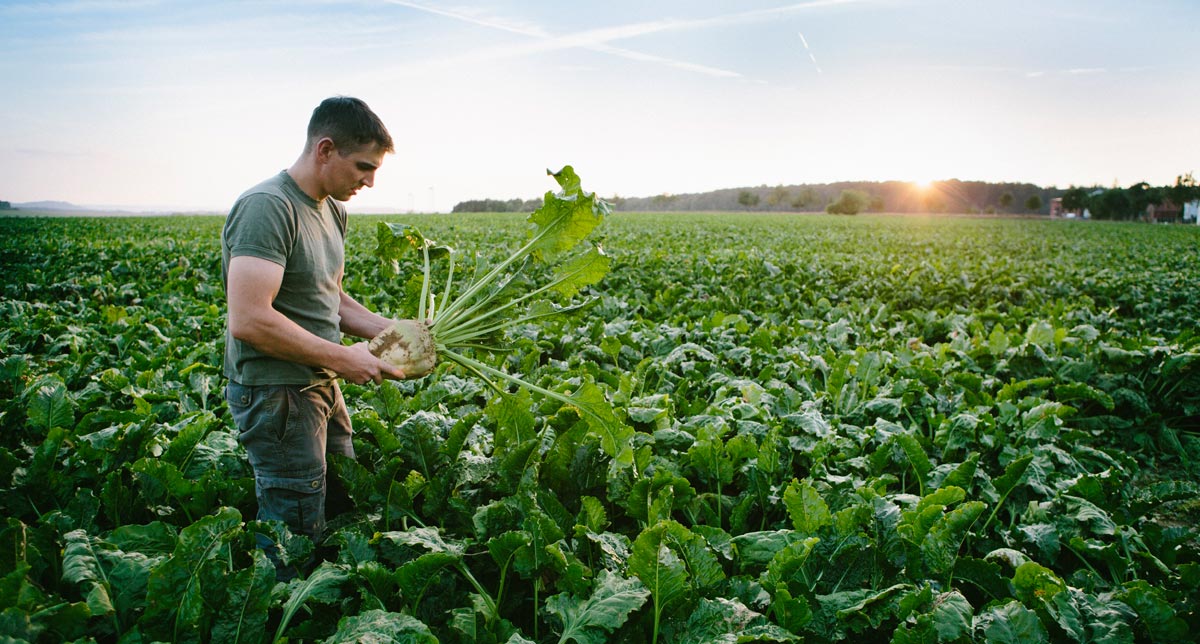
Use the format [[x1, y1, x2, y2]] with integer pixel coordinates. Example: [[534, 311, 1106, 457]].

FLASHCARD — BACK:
[[0, 207, 1200, 644]]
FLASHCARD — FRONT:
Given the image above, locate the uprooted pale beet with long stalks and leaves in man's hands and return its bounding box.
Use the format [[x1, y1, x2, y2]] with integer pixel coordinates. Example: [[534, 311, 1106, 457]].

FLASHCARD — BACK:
[[371, 165, 619, 431]]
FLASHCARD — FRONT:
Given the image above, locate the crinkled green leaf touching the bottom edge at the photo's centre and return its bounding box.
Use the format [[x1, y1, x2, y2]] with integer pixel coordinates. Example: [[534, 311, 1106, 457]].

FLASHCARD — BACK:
[[546, 570, 650, 644]]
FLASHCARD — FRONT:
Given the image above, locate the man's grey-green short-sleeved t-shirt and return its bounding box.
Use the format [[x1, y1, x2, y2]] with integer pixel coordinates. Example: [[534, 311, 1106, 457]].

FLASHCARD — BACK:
[[221, 170, 347, 385]]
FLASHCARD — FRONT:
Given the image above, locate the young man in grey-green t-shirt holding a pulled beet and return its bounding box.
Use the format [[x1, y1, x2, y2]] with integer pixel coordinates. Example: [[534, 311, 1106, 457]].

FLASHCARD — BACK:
[[221, 97, 404, 577]]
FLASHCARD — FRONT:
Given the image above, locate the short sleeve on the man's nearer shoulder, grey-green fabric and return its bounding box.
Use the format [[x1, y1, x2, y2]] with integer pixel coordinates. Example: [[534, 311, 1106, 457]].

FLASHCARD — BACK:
[[226, 193, 296, 266]]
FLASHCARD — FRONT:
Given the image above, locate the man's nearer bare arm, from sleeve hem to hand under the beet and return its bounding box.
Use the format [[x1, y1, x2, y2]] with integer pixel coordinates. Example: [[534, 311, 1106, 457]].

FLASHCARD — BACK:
[[227, 257, 404, 384]]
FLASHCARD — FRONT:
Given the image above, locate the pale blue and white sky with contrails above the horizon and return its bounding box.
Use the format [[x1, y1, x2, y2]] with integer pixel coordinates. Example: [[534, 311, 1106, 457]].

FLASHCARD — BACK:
[[0, 0, 1200, 212]]
